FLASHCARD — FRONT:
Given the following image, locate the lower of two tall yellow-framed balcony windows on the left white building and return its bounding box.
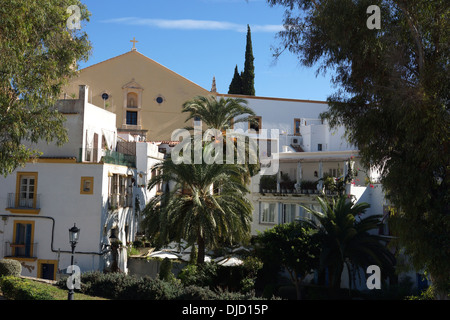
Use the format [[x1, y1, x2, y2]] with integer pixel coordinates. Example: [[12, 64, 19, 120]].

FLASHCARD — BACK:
[[11, 221, 34, 258]]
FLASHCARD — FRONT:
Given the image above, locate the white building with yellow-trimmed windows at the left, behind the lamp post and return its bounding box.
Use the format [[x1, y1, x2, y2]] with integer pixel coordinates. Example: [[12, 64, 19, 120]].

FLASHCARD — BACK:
[[0, 86, 163, 279]]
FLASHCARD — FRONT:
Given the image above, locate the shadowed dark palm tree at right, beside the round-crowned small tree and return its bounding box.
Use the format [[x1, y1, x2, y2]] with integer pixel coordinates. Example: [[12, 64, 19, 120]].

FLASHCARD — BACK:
[[302, 195, 395, 289]]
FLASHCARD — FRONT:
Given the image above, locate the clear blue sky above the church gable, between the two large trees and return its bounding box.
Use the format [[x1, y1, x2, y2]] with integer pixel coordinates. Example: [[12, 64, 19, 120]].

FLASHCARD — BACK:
[[80, 0, 335, 100]]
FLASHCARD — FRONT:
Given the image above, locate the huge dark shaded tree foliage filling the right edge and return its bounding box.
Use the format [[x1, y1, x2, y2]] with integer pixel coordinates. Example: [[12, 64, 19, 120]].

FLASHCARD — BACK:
[[268, 0, 450, 298]]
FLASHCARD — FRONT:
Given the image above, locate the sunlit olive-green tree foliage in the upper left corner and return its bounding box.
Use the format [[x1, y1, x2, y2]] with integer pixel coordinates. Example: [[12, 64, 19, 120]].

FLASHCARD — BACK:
[[0, 0, 91, 176]]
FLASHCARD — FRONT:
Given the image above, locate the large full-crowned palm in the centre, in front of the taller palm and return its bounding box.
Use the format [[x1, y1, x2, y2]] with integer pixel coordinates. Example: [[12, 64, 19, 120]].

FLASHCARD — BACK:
[[143, 157, 253, 264]]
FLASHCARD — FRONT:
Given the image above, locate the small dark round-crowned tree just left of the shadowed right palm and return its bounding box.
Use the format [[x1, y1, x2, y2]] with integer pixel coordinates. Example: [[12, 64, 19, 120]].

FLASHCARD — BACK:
[[256, 222, 321, 299]]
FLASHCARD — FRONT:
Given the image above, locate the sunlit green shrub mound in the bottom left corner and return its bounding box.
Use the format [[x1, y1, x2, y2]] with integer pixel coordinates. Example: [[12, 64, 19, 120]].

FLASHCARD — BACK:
[[0, 276, 55, 300]]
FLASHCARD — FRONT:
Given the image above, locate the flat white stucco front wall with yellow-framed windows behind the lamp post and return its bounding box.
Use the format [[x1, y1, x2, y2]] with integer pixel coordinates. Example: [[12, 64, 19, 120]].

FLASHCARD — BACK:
[[0, 163, 107, 276]]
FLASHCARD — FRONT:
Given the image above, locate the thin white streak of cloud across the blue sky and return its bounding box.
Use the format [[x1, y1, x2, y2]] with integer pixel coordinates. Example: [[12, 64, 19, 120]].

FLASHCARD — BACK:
[[101, 17, 283, 32]]
